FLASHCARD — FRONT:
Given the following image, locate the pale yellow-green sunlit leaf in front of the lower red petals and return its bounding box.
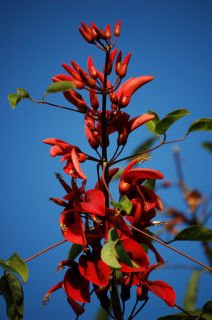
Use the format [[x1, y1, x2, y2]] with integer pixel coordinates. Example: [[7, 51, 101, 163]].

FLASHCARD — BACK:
[[101, 241, 121, 269]]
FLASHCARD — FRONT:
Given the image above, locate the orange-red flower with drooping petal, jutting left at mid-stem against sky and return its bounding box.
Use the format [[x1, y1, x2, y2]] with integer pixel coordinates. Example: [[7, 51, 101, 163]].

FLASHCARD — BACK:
[[43, 138, 87, 180]]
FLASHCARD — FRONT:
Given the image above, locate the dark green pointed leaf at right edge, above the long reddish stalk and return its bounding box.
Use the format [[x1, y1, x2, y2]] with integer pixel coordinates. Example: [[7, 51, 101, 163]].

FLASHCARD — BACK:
[[169, 226, 212, 242]]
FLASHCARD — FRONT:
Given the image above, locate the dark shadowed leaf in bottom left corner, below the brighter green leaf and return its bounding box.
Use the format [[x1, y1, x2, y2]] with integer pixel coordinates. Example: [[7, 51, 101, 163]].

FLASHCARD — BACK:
[[0, 273, 24, 320]]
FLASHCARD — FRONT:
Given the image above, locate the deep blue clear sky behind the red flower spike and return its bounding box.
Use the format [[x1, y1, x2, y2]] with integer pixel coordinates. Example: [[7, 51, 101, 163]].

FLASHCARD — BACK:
[[0, 0, 212, 320]]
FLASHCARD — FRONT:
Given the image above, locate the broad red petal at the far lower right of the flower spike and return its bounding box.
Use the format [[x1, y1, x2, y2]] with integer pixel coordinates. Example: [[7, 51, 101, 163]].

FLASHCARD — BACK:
[[145, 280, 176, 307]]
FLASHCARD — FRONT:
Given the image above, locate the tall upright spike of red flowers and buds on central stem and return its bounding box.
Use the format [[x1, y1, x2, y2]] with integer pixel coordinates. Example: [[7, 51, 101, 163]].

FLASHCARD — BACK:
[[43, 21, 175, 315]]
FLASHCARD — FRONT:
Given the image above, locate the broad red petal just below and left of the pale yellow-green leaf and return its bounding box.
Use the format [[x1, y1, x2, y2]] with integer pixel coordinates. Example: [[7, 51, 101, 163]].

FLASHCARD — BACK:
[[79, 255, 110, 287]]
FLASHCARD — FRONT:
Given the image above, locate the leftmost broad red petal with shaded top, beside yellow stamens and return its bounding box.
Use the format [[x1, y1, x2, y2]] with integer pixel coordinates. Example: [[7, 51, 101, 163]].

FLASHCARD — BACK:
[[59, 210, 87, 246]]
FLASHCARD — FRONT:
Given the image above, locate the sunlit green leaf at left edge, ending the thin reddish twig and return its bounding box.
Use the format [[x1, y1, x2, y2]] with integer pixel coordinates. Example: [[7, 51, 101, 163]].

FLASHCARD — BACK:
[[0, 253, 29, 283]]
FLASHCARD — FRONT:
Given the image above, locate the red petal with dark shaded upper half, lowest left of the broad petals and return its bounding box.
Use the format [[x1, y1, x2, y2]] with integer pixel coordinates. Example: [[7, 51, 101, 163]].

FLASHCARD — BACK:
[[64, 268, 90, 303]]
